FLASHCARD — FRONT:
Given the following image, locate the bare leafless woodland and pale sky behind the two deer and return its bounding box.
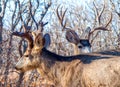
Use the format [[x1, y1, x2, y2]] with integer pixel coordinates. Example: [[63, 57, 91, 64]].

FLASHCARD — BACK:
[[0, 0, 120, 87]]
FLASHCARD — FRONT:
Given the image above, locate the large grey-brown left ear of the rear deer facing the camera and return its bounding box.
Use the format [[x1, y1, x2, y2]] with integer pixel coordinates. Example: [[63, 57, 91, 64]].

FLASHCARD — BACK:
[[66, 29, 80, 45]]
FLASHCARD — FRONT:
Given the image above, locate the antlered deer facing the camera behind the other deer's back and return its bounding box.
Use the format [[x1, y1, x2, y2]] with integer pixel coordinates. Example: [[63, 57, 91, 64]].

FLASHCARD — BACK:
[[56, 4, 112, 55]]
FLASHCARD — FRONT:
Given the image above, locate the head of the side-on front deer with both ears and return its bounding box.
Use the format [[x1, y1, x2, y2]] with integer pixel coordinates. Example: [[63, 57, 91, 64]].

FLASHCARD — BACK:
[[13, 32, 50, 72]]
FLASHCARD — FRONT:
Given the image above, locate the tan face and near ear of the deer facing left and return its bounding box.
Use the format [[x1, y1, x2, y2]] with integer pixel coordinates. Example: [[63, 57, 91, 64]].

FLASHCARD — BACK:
[[15, 33, 50, 72]]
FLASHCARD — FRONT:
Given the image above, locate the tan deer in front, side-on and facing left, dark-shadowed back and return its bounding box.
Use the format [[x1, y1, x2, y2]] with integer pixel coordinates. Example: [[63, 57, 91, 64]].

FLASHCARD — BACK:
[[12, 32, 120, 87]]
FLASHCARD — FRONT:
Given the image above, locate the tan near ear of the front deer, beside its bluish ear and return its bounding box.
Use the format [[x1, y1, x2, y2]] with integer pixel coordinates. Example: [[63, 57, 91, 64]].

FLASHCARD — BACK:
[[34, 33, 44, 47]]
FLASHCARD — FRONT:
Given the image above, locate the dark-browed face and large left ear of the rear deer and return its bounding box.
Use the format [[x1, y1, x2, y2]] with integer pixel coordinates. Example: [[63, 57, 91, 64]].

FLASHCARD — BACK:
[[66, 29, 91, 53]]
